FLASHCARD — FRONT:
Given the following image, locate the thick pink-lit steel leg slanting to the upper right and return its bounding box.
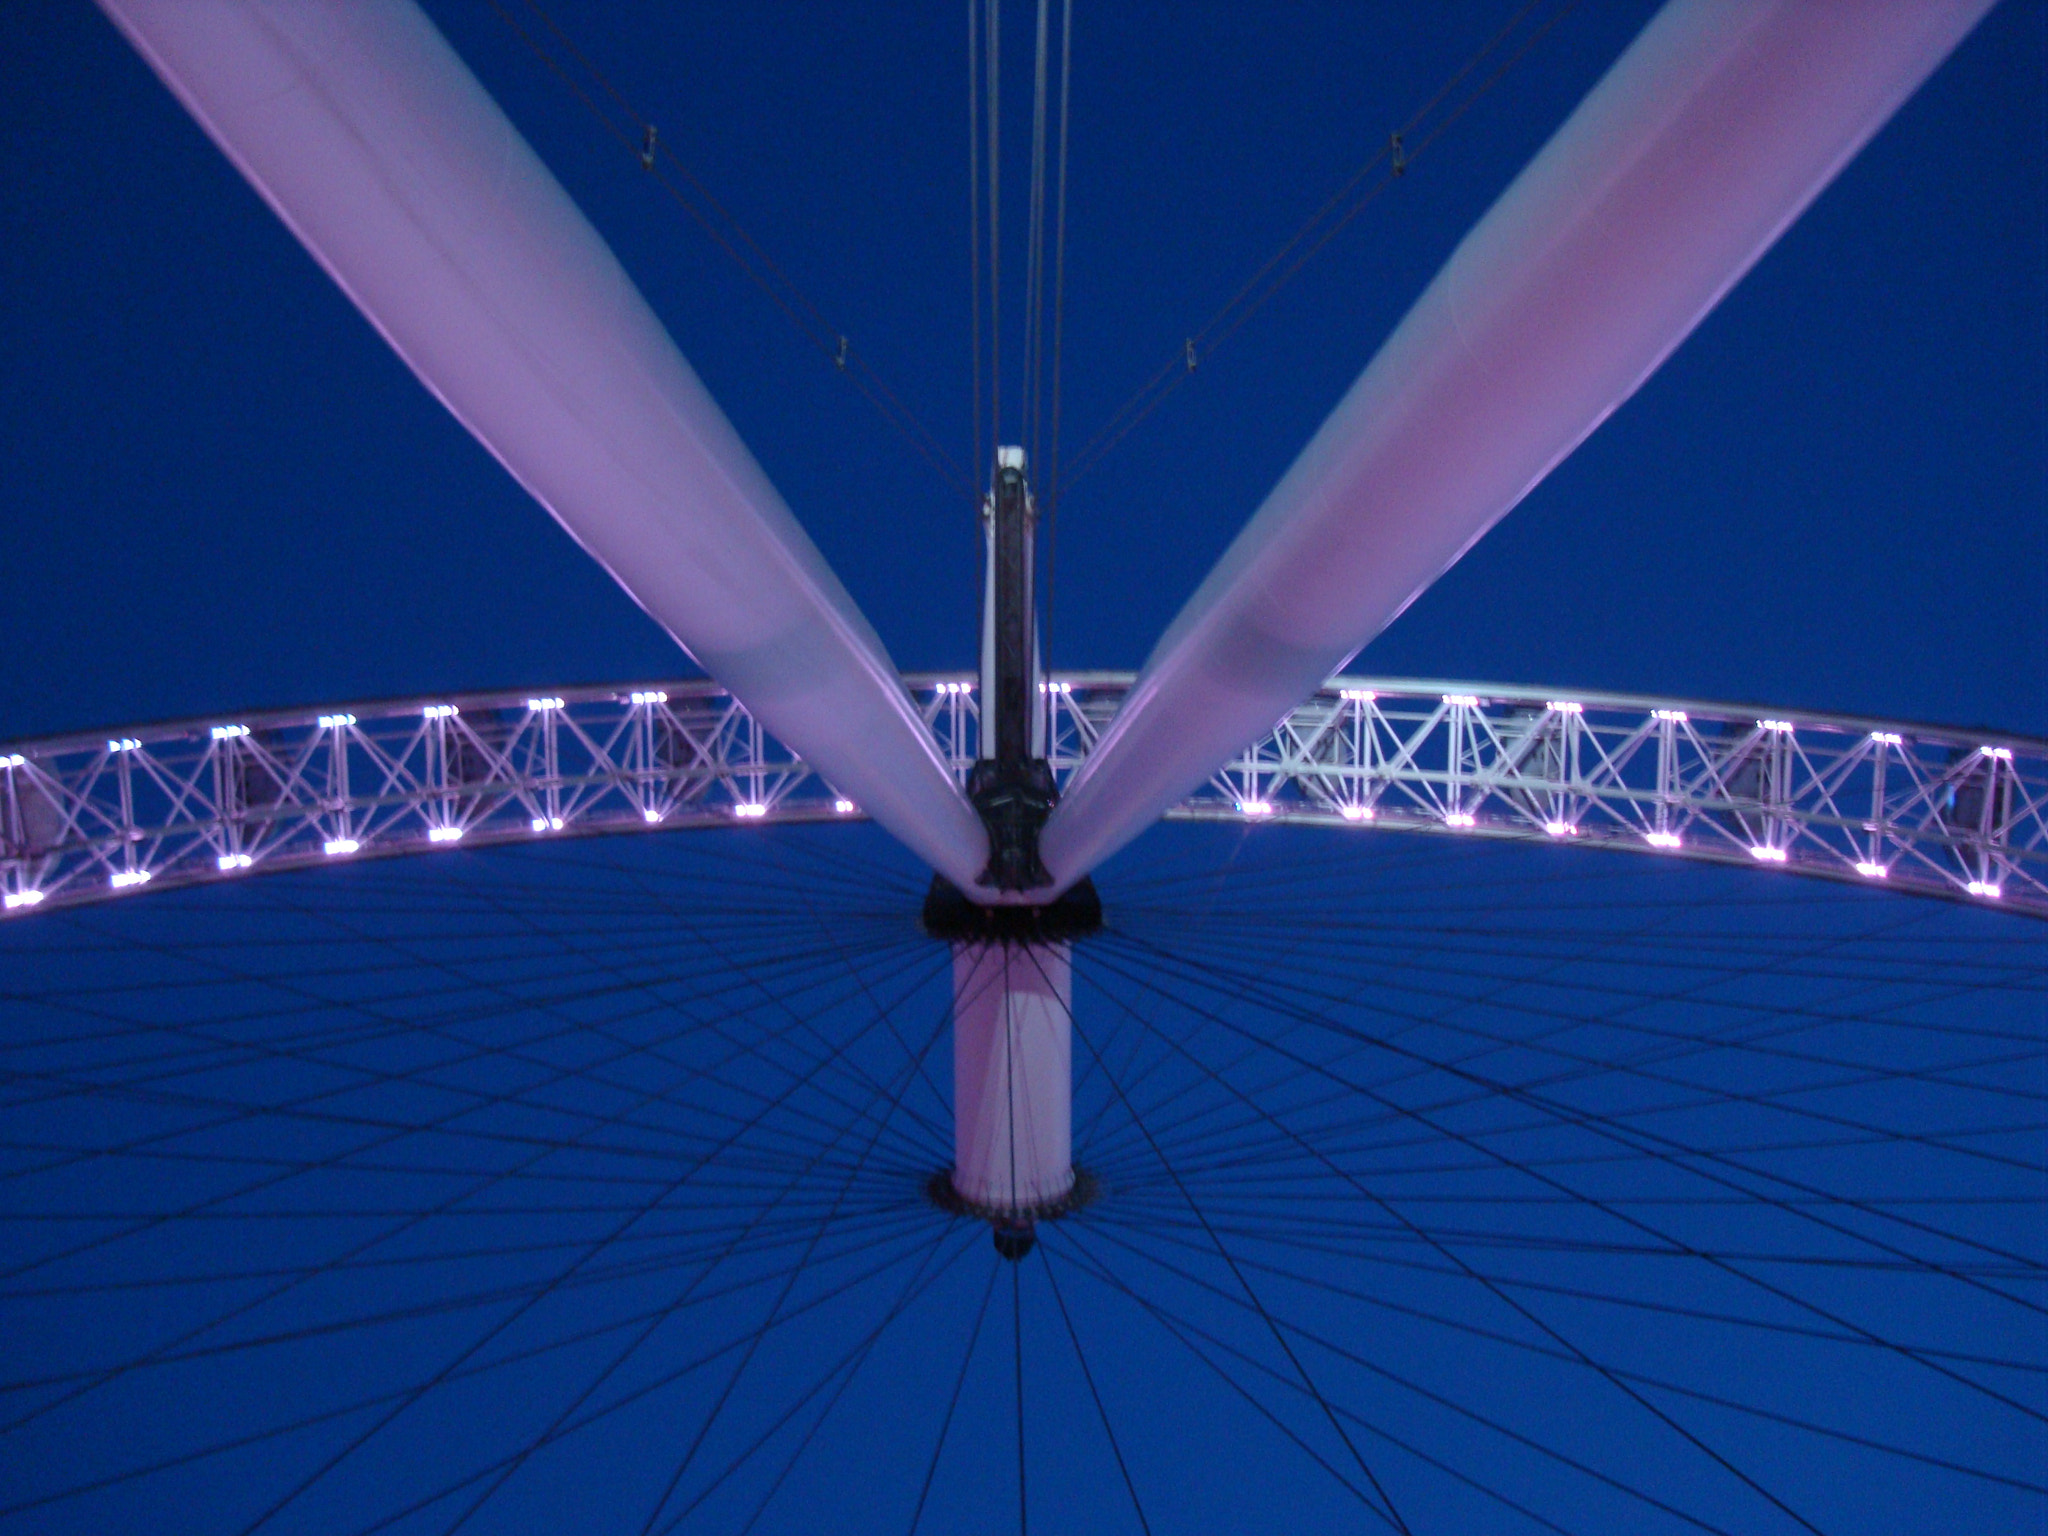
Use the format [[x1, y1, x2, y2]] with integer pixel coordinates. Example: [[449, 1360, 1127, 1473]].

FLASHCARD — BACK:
[[1042, 0, 1991, 887]]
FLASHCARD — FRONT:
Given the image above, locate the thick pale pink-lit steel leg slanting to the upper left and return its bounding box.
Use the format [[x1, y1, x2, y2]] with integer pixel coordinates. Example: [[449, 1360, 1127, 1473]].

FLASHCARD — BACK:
[[102, 0, 987, 887]]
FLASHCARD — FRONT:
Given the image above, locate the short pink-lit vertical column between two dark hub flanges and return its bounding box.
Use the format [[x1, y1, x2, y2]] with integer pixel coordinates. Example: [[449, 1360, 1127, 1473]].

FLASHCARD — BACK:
[[952, 942, 1073, 1214]]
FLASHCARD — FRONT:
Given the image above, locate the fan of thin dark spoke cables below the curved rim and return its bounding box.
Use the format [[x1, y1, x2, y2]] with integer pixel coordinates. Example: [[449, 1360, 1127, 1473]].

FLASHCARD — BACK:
[[0, 825, 2048, 1532]]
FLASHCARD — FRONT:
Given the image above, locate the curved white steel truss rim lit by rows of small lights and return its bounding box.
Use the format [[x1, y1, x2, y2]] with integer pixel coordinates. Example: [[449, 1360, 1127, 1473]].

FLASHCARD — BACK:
[[0, 672, 2048, 918]]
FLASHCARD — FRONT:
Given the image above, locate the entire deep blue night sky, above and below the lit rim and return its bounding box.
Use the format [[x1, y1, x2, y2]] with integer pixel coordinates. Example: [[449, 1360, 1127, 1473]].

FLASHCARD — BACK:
[[0, 0, 2048, 1532]]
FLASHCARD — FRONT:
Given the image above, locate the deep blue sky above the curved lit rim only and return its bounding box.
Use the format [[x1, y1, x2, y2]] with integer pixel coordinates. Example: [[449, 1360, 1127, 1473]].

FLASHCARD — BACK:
[[0, 0, 2048, 737]]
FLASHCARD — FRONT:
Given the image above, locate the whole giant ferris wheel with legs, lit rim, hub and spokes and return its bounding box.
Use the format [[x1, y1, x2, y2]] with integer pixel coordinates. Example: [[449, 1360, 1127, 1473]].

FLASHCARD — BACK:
[[0, 0, 2048, 1536]]
